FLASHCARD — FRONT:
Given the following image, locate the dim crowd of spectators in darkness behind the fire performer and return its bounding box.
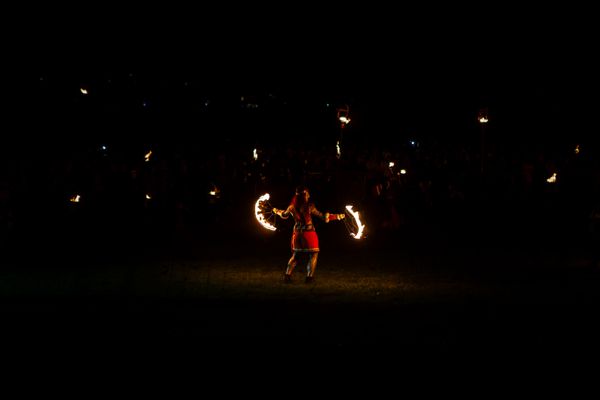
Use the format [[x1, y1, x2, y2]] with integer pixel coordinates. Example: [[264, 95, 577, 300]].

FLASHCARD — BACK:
[[0, 127, 600, 260]]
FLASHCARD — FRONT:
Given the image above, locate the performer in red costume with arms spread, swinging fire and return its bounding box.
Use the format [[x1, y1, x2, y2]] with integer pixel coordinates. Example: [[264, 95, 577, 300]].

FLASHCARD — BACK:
[[272, 186, 346, 283]]
